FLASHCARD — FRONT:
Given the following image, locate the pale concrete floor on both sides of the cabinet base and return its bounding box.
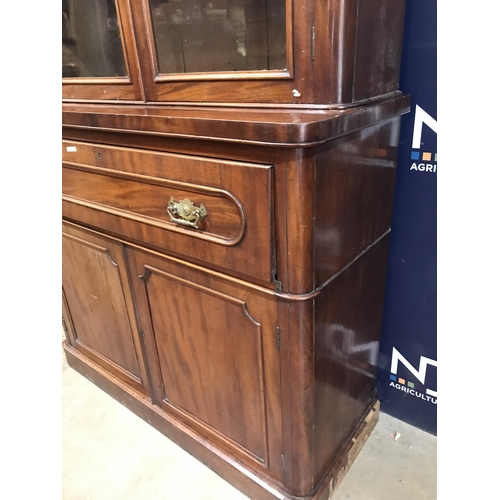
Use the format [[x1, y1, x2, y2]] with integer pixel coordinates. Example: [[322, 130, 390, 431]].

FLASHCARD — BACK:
[[62, 356, 437, 500]]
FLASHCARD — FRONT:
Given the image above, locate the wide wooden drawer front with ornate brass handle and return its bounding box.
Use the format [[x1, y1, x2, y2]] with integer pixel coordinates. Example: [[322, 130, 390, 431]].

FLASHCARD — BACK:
[[62, 141, 274, 282]]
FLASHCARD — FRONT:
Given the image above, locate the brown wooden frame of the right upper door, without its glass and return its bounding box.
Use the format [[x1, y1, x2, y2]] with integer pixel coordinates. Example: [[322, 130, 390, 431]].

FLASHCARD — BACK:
[[132, 0, 308, 103]]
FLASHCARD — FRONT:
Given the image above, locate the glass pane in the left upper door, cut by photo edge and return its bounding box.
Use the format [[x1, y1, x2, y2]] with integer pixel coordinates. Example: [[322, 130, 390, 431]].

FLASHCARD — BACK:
[[62, 0, 127, 78]]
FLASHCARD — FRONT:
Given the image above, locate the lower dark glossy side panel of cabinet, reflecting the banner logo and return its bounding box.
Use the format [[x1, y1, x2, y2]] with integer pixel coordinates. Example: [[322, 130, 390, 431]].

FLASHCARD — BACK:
[[314, 235, 389, 484]]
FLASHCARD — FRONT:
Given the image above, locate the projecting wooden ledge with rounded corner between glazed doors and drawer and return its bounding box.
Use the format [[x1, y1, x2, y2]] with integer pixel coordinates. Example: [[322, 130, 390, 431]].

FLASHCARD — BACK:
[[62, 93, 410, 147]]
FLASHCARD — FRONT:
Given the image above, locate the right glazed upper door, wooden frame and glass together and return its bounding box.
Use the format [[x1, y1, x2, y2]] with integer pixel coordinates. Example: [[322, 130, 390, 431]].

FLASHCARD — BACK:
[[127, 0, 314, 104]]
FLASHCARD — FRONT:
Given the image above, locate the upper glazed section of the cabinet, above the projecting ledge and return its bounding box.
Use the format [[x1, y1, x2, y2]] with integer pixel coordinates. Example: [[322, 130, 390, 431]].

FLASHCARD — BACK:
[[62, 0, 406, 109]]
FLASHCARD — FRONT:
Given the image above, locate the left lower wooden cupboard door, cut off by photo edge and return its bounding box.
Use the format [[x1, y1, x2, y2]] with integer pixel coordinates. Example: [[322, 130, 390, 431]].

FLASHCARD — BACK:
[[62, 224, 147, 392]]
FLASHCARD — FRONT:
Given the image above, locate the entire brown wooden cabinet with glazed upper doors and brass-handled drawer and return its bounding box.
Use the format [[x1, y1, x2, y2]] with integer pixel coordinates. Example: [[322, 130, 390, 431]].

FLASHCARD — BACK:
[[62, 0, 409, 500]]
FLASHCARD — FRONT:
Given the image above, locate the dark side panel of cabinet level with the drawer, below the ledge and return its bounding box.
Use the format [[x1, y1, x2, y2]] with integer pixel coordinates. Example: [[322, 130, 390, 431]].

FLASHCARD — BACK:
[[314, 118, 400, 287]]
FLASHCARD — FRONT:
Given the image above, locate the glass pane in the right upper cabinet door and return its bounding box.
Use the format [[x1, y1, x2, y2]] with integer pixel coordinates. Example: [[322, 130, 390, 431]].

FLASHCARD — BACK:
[[149, 0, 286, 73]]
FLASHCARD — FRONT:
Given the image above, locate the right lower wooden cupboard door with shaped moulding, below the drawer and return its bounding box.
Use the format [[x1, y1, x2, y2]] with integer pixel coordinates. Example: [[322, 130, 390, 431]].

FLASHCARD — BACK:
[[127, 248, 282, 483]]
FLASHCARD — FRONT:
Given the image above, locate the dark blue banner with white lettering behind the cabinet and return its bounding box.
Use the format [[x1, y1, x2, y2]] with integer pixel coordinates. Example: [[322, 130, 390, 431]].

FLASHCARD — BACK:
[[377, 0, 437, 434]]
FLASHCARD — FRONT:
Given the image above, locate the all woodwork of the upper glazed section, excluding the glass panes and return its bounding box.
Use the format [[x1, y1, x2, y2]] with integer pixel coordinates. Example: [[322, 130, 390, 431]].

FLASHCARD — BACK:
[[63, 0, 405, 107]]
